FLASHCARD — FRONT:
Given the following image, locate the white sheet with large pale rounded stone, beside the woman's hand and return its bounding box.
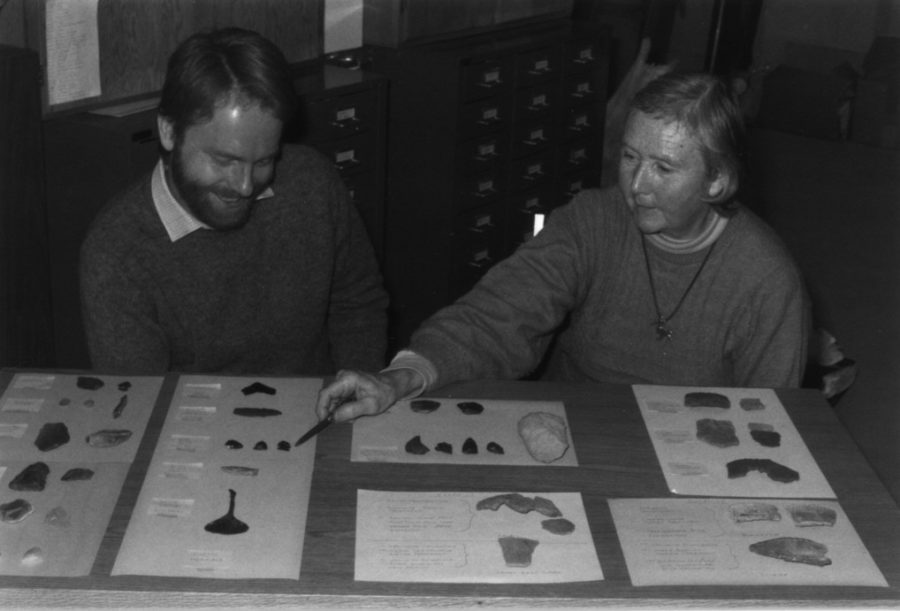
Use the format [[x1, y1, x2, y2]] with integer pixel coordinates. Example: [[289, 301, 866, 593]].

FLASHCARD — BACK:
[[351, 399, 578, 467]]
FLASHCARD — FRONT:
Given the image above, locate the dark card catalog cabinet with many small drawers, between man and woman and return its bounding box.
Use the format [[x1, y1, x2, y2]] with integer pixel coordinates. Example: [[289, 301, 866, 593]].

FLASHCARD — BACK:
[[366, 21, 608, 347]]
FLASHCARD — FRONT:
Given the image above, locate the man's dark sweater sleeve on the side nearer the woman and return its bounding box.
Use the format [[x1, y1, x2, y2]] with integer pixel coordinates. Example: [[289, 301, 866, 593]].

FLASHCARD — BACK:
[[325, 167, 388, 371]]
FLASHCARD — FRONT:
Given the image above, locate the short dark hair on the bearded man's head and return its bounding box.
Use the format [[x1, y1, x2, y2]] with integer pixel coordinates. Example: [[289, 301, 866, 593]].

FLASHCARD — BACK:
[[159, 28, 297, 137]]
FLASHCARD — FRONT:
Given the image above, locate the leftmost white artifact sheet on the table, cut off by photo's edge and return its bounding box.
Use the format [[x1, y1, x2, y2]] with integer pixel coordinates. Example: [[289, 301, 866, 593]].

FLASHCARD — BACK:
[[0, 373, 163, 577]]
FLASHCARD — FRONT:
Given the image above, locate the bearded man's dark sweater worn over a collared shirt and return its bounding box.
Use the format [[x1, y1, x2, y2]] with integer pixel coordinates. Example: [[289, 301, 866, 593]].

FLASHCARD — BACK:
[[80, 146, 387, 375]]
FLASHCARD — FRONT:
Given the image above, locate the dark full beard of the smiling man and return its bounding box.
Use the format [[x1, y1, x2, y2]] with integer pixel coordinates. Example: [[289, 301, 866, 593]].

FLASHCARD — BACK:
[[169, 146, 262, 231]]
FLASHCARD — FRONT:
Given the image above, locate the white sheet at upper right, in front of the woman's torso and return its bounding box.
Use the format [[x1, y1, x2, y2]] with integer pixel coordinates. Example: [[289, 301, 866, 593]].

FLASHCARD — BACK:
[[633, 385, 835, 498]]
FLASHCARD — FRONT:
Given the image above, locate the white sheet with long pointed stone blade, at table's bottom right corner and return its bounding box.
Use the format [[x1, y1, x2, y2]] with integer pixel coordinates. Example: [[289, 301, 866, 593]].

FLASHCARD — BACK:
[[609, 498, 888, 587]]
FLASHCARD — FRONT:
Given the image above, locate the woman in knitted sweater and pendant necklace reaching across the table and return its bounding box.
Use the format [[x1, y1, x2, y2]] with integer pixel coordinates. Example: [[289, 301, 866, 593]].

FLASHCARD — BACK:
[[317, 73, 809, 421]]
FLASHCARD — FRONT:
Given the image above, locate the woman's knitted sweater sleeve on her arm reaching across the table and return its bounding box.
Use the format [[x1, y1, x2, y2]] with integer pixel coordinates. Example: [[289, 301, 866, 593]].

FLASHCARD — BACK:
[[410, 194, 592, 385]]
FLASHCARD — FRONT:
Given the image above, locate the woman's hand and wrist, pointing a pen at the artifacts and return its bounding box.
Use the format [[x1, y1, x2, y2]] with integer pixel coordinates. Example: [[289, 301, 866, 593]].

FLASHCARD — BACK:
[[316, 369, 424, 422]]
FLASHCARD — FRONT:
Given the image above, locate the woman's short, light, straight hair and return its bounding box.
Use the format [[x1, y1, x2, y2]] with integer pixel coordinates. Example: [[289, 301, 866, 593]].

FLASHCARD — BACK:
[[631, 72, 746, 202]]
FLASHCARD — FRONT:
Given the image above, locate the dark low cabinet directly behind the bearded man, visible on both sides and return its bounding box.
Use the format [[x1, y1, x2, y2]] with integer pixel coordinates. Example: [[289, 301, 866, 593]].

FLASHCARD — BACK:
[[44, 62, 387, 367]]
